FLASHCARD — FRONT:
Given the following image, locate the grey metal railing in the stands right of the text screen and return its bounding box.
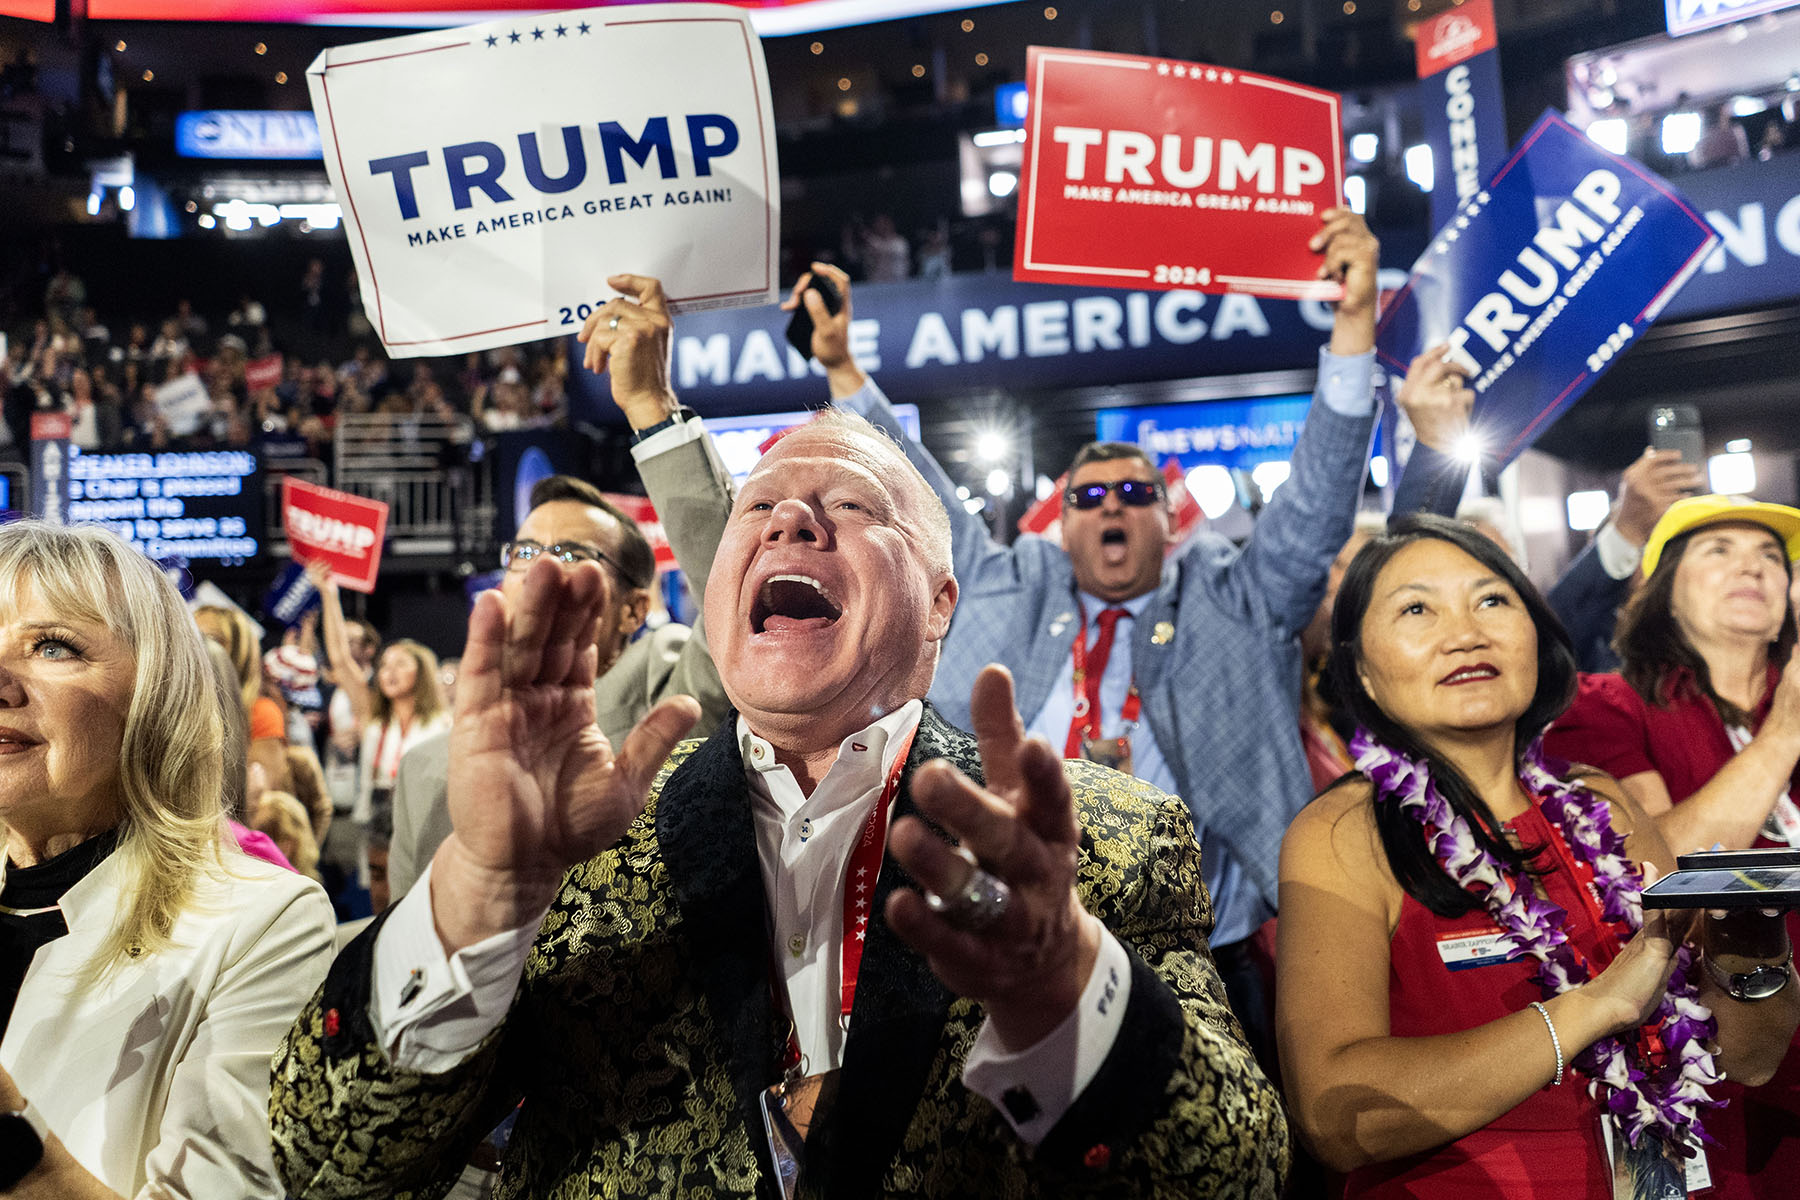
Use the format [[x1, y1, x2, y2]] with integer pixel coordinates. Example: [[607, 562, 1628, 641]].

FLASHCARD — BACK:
[[333, 412, 493, 556]]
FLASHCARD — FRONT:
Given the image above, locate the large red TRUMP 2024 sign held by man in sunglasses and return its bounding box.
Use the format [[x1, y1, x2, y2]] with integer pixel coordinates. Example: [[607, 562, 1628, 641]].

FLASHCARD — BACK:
[[1013, 47, 1343, 300]]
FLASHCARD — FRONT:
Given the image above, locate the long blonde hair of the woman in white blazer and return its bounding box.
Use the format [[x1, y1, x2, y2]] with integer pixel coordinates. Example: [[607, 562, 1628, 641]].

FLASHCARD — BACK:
[[0, 522, 225, 984]]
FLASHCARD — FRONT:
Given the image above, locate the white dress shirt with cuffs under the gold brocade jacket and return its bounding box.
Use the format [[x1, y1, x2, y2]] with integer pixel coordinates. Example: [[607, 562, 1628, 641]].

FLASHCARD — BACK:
[[369, 700, 1130, 1146]]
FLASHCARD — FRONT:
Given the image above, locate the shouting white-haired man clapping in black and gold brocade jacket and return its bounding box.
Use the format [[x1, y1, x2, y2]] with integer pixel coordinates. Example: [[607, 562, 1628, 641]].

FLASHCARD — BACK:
[[272, 284, 1287, 1200]]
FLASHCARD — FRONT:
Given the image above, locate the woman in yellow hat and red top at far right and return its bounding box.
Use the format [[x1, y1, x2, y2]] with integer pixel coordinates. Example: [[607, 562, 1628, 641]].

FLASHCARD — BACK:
[[1544, 497, 1800, 1200]]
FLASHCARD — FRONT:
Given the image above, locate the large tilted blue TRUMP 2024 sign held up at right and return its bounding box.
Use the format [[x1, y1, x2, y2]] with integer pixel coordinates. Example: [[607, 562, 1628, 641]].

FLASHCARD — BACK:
[[1375, 113, 1719, 464]]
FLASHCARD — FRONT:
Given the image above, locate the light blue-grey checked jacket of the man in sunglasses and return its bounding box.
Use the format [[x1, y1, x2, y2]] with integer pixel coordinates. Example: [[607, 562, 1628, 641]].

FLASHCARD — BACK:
[[837, 370, 1375, 909]]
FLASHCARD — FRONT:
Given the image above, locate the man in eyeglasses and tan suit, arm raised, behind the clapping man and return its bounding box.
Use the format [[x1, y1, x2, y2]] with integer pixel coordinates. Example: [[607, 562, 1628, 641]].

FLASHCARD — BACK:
[[387, 275, 733, 900]]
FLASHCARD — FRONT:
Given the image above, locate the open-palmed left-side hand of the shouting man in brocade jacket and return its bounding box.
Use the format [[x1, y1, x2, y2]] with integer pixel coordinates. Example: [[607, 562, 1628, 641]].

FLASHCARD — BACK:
[[432, 556, 700, 952]]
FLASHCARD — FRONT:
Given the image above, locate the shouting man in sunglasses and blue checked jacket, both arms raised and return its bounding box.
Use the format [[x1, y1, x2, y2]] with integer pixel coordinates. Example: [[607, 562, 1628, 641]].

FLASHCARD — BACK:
[[810, 209, 1379, 1063]]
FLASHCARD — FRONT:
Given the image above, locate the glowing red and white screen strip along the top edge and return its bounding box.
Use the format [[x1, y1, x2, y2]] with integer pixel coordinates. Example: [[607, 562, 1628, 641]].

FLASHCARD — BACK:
[[87, 0, 1006, 36]]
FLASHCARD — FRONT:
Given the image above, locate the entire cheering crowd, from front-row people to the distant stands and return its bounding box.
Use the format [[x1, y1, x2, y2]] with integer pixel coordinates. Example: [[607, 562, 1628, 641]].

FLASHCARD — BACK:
[[0, 209, 1800, 1200]]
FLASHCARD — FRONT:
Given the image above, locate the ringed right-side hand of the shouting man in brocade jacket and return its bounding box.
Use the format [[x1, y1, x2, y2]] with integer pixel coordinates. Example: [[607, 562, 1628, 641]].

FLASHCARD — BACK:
[[887, 666, 1102, 1049]]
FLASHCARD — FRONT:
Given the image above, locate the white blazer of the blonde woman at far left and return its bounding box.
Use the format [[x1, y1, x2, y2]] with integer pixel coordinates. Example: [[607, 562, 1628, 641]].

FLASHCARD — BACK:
[[0, 847, 333, 1200]]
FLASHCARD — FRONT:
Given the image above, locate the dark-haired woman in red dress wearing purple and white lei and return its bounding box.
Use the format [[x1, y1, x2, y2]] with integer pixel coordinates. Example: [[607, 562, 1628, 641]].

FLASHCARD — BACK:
[[1276, 516, 1800, 1200]]
